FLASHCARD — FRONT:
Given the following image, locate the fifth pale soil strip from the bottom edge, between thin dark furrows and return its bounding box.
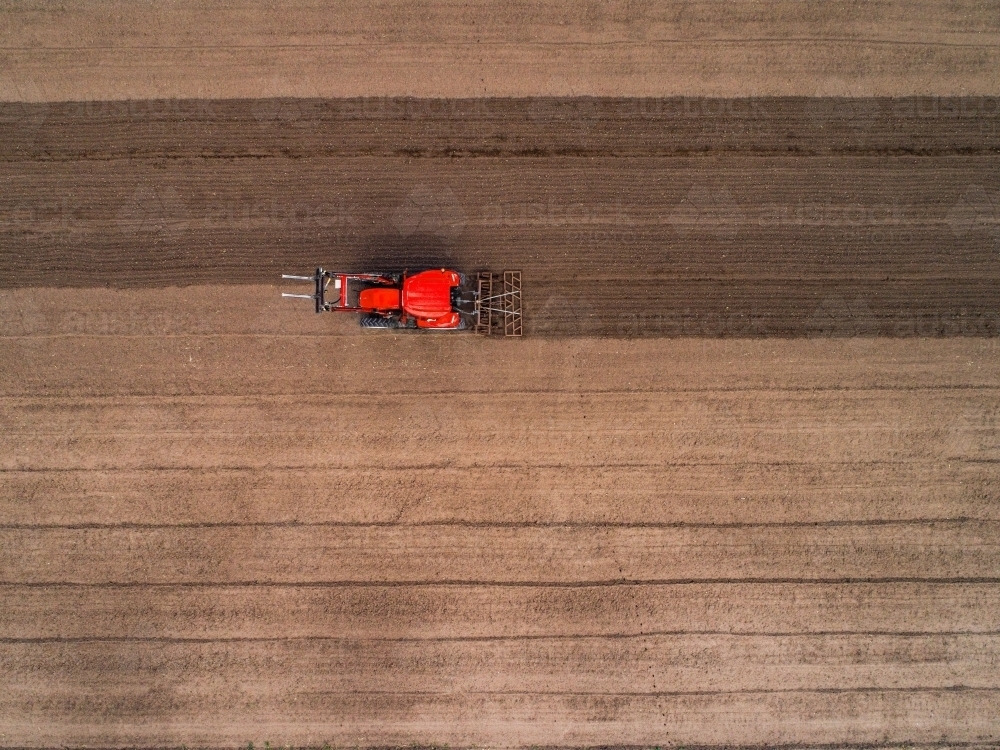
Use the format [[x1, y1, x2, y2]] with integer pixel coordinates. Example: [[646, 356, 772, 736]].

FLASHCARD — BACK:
[[0, 460, 1000, 528]]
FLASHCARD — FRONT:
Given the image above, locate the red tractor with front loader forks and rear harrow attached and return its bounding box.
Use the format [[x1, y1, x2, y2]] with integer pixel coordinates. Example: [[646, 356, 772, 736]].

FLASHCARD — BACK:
[[281, 268, 521, 336]]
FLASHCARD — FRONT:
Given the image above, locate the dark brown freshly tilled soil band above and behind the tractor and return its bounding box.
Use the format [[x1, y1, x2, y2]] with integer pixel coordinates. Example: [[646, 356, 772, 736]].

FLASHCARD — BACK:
[[0, 98, 1000, 337]]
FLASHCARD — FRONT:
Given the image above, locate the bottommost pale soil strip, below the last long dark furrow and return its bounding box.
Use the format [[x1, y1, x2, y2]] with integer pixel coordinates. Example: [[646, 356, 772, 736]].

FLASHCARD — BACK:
[[0, 692, 1000, 748]]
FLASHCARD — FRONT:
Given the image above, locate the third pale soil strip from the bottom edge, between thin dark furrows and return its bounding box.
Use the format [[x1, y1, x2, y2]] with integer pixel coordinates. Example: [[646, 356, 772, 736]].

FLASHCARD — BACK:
[[0, 582, 1000, 642]]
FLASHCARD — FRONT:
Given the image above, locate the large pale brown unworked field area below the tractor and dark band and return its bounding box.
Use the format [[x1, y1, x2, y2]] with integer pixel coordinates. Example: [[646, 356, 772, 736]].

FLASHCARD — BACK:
[[0, 286, 1000, 747]]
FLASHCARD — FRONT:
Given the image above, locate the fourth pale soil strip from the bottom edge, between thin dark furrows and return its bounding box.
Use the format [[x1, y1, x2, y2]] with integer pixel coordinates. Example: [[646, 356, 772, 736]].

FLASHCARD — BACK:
[[0, 521, 1000, 585]]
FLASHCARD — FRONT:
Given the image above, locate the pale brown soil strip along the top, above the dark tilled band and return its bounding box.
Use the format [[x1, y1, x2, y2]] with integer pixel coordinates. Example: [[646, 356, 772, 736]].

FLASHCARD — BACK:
[[0, 0, 1000, 101]]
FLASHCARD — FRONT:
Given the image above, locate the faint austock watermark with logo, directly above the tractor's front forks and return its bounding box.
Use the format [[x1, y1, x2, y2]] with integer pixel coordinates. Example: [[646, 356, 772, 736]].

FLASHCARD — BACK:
[[116, 185, 355, 237]]
